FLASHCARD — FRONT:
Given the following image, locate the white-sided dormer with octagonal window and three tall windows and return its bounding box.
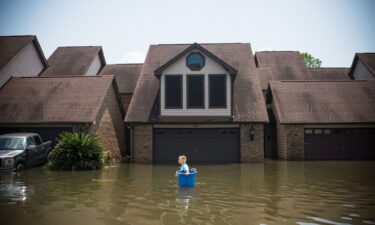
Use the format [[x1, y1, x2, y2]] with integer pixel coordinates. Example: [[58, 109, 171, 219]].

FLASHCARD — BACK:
[[154, 43, 237, 117]]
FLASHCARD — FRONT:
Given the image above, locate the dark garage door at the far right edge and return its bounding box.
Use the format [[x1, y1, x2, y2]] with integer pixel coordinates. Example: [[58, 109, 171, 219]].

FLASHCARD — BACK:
[[305, 128, 375, 160]]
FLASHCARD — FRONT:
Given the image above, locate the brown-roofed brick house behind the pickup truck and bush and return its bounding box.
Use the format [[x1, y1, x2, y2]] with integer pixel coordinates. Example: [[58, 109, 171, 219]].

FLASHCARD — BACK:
[[0, 75, 125, 158]]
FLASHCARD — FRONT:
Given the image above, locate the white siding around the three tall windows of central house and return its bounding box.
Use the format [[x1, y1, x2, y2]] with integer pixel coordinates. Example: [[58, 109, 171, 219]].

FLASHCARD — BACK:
[[160, 51, 232, 116]]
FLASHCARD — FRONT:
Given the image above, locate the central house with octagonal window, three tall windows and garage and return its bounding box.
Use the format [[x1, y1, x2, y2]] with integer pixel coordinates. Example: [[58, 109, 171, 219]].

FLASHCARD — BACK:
[[125, 43, 268, 163]]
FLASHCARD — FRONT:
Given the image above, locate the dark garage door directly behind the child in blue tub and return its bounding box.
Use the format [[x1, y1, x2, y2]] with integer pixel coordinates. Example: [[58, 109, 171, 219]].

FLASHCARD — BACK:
[[154, 128, 240, 163]]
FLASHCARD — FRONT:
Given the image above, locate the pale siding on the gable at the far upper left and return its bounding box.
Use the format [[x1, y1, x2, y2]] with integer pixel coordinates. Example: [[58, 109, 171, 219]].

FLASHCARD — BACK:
[[0, 42, 44, 87]]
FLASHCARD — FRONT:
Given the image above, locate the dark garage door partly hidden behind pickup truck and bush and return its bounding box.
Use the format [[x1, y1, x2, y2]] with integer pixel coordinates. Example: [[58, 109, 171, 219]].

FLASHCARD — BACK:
[[0, 127, 72, 144]]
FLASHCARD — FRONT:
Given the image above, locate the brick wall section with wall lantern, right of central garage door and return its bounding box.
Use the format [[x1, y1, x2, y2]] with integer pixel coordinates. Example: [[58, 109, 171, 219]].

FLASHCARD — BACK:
[[240, 124, 264, 163]]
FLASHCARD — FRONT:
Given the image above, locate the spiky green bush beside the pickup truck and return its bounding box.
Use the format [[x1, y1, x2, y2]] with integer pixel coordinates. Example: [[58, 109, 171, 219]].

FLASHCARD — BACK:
[[48, 132, 104, 170]]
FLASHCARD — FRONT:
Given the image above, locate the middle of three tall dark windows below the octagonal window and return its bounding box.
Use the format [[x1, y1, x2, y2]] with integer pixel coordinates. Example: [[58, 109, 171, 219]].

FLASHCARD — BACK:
[[187, 75, 204, 108]]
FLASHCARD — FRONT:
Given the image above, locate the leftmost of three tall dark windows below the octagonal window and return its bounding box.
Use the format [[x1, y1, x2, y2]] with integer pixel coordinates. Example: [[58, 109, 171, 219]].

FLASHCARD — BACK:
[[165, 75, 182, 108]]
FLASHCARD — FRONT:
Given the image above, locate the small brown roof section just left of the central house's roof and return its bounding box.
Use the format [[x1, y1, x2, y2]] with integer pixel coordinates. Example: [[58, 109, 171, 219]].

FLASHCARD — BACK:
[[100, 64, 143, 94]]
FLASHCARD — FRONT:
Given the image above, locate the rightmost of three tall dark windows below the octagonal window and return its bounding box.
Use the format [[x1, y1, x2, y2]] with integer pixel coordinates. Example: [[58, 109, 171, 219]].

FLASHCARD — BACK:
[[209, 75, 227, 108]]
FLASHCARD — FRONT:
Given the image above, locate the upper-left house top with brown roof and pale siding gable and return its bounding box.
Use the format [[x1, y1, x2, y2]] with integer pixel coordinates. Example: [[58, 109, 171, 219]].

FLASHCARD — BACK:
[[0, 35, 48, 88]]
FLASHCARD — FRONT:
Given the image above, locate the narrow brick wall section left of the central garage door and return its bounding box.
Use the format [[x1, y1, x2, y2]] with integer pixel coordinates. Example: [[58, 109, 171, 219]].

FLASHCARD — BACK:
[[132, 124, 152, 163]]
